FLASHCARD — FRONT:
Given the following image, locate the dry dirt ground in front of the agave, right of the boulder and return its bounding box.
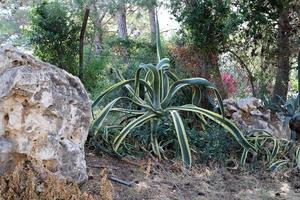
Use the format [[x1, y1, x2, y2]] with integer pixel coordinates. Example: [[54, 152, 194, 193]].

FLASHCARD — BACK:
[[80, 152, 300, 200]]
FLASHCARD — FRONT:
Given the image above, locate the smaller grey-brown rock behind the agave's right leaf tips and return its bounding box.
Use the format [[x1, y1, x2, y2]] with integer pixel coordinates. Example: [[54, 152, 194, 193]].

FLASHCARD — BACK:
[[223, 97, 291, 139]]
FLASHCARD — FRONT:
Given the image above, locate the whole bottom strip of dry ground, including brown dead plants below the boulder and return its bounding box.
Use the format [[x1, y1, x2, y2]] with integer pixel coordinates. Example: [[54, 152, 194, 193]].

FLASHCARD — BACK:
[[0, 153, 300, 200]]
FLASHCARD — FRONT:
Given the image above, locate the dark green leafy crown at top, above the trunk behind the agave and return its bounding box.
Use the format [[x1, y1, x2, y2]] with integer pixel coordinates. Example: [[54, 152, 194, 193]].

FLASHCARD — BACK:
[[171, 0, 241, 52]]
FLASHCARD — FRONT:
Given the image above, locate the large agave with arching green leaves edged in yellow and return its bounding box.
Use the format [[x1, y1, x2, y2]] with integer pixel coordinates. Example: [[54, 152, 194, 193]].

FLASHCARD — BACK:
[[93, 58, 253, 168]]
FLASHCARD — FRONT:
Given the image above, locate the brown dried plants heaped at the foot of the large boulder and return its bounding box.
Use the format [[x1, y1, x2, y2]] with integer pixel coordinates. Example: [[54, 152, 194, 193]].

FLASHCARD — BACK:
[[0, 159, 94, 200]]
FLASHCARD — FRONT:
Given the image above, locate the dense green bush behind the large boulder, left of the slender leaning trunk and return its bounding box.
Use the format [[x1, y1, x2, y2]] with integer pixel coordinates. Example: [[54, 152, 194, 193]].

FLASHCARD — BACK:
[[26, 1, 80, 74]]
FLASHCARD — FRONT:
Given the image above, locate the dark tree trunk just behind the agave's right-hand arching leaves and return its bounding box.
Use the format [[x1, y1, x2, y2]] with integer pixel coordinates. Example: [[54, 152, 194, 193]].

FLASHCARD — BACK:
[[204, 52, 228, 99]]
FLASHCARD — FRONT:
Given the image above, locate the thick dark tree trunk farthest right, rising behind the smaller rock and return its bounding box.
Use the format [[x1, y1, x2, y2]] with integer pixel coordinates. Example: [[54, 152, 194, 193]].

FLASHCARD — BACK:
[[273, 10, 291, 104]]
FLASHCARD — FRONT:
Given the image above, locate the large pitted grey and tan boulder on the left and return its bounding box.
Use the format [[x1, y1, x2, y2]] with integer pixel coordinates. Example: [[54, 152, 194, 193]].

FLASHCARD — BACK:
[[0, 47, 91, 182]]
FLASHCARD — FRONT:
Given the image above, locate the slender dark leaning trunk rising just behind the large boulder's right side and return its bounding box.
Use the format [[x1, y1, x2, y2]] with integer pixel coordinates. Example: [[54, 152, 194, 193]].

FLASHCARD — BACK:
[[78, 8, 90, 80]]
